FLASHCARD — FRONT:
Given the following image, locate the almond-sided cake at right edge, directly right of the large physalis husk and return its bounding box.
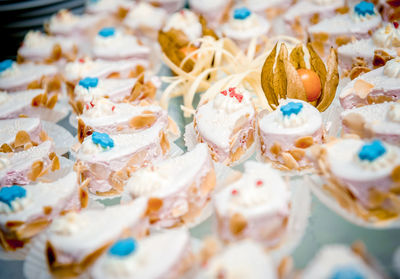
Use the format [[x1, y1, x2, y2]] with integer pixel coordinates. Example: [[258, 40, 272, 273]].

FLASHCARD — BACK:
[[339, 57, 400, 109]]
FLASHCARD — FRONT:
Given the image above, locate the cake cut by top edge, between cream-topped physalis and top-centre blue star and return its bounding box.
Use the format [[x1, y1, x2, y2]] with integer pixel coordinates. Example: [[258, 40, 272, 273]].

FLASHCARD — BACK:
[[189, 0, 232, 28]]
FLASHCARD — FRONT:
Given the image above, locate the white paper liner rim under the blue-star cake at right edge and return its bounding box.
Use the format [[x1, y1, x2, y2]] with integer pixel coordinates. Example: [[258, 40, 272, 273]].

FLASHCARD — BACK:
[[305, 175, 400, 229]]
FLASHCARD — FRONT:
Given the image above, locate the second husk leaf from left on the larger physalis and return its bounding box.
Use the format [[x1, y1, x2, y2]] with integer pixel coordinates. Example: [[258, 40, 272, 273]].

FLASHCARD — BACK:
[[273, 44, 288, 99]]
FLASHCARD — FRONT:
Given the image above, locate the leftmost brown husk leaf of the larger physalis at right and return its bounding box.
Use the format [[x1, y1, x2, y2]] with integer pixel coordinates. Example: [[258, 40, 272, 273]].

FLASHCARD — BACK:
[[261, 43, 279, 106]]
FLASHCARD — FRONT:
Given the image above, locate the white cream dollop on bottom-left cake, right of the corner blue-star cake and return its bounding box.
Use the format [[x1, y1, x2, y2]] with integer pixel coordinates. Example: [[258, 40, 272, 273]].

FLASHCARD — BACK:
[[50, 211, 84, 235]]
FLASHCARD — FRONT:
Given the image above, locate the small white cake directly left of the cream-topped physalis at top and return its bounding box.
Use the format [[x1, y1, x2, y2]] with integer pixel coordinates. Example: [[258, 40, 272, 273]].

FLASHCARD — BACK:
[[123, 2, 167, 41]]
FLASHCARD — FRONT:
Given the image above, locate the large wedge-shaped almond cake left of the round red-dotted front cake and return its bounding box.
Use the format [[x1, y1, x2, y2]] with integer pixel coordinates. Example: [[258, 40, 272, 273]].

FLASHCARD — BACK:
[[126, 144, 216, 227]]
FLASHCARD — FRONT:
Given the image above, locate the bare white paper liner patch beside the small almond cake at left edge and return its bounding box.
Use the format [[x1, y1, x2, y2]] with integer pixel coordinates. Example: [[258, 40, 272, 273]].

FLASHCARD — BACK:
[[42, 121, 74, 155]]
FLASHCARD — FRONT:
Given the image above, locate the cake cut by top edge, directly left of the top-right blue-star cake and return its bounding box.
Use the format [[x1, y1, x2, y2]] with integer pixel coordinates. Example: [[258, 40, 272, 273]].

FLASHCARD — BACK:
[[283, 0, 348, 38]]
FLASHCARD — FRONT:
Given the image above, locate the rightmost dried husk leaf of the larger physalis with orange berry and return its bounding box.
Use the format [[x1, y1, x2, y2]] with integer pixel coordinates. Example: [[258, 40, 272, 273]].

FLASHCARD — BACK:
[[317, 48, 339, 111]]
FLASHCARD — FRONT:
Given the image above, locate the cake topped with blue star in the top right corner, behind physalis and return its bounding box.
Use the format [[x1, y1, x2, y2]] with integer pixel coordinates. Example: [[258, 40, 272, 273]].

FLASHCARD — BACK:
[[308, 1, 382, 55]]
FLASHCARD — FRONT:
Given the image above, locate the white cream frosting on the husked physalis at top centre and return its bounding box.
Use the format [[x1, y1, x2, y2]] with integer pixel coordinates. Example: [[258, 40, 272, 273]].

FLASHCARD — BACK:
[[164, 9, 202, 41]]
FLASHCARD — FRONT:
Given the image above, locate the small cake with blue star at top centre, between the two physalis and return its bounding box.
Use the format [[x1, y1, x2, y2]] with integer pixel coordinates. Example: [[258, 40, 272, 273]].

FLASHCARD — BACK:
[[220, 7, 271, 50]]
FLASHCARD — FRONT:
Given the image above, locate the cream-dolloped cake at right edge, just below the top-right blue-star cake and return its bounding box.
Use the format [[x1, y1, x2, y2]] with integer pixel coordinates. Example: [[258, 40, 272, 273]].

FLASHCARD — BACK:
[[337, 23, 400, 71]]
